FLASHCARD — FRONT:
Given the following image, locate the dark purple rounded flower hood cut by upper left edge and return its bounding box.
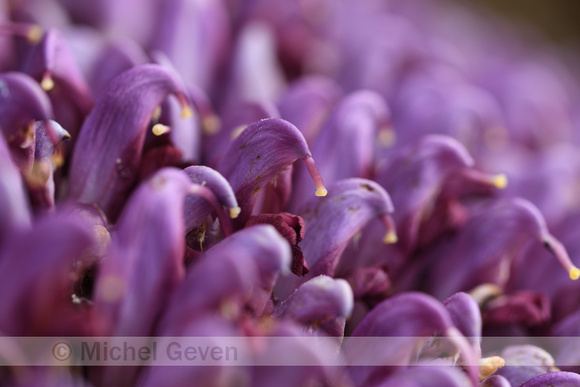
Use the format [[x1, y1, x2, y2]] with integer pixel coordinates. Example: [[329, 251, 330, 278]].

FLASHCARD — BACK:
[[0, 72, 56, 142]]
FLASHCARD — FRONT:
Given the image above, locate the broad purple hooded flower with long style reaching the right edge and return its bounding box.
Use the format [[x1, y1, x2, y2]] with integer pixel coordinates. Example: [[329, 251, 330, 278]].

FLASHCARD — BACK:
[[426, 199, 580, 297]]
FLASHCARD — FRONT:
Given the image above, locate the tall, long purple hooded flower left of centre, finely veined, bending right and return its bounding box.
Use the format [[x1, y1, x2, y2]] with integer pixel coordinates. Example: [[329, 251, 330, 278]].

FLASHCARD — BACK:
[[69, 64, 191, 219]]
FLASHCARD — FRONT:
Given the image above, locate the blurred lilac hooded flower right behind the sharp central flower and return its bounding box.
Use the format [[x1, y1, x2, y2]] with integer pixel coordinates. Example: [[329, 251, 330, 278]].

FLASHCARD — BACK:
[[292, 90, 392, 209]]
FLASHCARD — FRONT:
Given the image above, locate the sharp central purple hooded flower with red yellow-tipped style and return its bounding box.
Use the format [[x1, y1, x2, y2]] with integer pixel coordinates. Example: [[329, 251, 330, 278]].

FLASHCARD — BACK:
[[218, 118, 326, 225]]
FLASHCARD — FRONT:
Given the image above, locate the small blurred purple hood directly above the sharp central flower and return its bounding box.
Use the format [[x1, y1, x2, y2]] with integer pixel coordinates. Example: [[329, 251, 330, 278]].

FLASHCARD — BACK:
[[277, 75, 343, 144]]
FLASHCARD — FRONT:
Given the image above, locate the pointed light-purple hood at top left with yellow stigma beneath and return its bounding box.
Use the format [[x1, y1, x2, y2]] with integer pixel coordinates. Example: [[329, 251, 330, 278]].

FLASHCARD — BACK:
[[26, 29, 94, 116]]
